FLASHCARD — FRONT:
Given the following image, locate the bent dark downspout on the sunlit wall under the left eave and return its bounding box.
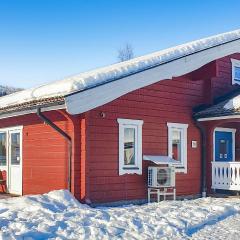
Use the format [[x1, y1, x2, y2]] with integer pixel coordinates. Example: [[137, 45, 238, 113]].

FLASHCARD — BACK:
[[37, 108, 72, 192]]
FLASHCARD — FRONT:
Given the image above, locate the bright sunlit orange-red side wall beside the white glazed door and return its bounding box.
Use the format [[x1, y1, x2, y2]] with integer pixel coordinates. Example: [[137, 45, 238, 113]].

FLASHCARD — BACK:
[[0, 111, 72, 194]]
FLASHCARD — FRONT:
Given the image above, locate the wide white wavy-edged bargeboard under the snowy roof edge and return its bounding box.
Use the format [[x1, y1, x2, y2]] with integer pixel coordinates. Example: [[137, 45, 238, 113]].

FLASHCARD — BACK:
[[65, 39, 240, 115]]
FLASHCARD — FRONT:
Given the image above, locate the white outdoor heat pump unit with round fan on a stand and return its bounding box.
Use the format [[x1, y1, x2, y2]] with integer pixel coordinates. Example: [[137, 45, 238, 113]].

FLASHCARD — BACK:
[[148, 166, 175, 188]]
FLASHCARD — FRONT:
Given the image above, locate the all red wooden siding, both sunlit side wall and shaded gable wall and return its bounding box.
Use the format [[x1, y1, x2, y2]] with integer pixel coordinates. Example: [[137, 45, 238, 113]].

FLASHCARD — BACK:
[[0, 55, 240, 203]]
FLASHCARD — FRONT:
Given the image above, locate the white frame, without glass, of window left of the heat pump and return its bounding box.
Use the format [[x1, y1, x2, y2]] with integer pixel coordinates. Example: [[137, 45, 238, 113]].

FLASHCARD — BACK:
[[117, 118, 143, 175]]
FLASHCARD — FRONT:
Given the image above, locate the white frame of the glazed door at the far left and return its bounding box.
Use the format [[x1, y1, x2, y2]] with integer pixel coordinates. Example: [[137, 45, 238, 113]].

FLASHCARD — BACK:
[[0, 125, 23, 195]]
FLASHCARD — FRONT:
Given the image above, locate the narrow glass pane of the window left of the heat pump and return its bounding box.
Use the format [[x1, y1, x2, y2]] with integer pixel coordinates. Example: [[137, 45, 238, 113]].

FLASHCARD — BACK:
[[124, 128, 136, 165]]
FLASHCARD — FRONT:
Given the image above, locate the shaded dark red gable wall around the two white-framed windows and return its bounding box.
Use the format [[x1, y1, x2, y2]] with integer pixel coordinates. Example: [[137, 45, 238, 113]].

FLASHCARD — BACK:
[[87, 55, 240, 202]]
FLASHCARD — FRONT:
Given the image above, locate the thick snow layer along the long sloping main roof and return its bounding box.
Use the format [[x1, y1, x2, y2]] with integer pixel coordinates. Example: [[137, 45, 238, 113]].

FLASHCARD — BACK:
[[0, 30, 240, 113]]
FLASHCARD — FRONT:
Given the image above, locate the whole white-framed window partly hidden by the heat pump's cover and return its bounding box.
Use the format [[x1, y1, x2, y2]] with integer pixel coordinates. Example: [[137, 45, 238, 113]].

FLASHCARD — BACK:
[[167, 123, 188, 173]]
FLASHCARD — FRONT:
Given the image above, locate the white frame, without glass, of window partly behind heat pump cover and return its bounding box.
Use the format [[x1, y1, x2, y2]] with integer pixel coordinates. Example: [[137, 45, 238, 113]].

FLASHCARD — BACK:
[[167, 123, 188, 173]]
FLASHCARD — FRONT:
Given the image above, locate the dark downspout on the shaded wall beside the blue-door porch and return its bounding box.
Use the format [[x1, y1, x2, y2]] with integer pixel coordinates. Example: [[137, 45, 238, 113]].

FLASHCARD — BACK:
[[195, 119, 207, 197]]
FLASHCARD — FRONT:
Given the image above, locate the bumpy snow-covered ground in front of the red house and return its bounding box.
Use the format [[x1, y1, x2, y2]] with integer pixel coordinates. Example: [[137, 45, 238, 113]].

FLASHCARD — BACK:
[[0, 190, 240, 239]]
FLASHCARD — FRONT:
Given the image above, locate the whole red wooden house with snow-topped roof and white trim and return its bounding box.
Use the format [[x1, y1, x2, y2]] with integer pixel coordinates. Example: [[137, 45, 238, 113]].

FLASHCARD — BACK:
[[0, 30, 240, 203]]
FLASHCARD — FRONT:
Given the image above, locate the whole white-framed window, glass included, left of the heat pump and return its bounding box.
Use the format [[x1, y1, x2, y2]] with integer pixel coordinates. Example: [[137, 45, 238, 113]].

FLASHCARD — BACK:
[[118, 119, 143, 175]]
